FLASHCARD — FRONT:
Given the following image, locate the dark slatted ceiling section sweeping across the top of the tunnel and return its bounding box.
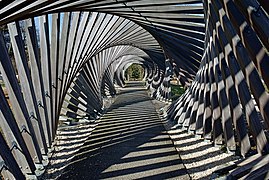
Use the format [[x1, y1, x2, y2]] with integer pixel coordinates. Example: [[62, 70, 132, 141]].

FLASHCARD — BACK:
[[0, 0, 204, 80]]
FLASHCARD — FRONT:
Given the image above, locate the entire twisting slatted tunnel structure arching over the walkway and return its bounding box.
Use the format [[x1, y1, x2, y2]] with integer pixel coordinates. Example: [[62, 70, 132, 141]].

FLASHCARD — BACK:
[[0, 0, 269, 179]]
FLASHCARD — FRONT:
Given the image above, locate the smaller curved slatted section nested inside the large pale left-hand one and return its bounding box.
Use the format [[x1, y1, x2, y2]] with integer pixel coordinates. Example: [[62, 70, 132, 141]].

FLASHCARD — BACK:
[[61, 45, 153, 121]]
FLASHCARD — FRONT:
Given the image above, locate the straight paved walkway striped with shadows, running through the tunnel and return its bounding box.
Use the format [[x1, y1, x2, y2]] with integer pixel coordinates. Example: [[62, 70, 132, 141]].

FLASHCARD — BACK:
[[59, 84, 189, 180]]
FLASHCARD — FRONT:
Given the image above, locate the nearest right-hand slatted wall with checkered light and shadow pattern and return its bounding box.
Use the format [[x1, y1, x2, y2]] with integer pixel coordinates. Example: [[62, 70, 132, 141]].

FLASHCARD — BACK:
[[165, 0, 269, 170]]
